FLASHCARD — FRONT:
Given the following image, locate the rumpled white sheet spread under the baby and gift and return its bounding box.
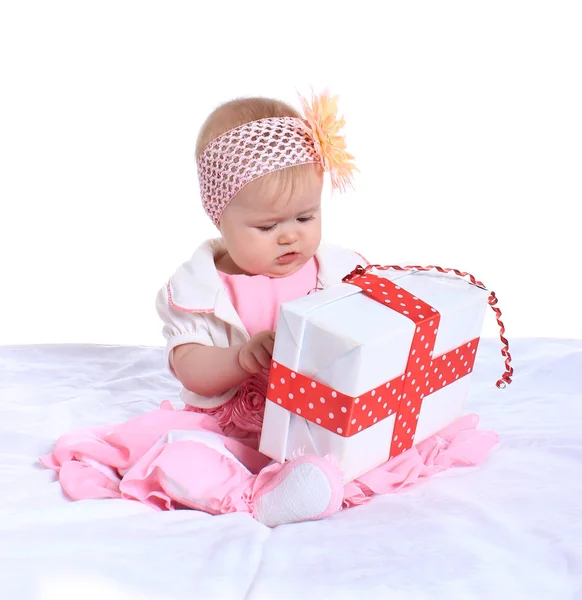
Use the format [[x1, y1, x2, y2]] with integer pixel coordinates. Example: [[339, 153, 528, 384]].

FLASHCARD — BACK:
[[0, 339, 582, 600]]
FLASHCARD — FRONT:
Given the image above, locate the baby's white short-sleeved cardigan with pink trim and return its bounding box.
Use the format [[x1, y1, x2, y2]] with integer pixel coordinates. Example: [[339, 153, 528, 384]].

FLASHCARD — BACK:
[[156, 238, 368, 408]]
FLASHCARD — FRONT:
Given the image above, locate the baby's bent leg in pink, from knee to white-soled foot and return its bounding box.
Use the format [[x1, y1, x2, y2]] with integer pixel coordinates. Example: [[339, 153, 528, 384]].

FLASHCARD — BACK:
[[120, 431, 343, 527]]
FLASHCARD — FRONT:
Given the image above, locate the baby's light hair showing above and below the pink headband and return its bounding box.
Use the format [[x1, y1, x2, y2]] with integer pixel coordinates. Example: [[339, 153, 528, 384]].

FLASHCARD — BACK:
[[196, 97, 323, 199]]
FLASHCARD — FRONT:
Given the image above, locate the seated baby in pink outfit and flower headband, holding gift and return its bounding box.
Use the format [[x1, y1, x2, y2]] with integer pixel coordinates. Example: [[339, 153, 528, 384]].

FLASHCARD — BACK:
[[41, 89, 497, 526]]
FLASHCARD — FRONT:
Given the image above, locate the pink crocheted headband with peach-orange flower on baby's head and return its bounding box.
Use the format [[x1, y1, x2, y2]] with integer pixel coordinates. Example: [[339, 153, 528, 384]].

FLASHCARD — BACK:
[[197, 94, 357, 224]]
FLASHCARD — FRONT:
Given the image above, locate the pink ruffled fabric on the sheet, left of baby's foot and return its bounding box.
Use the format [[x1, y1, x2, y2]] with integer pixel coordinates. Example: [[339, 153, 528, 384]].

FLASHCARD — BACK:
[[40, 401, 270, 514]]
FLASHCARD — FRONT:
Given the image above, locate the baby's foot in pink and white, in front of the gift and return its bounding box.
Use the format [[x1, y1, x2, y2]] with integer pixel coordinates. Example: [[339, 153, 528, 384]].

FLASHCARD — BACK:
[[251, 456, 344, 527]]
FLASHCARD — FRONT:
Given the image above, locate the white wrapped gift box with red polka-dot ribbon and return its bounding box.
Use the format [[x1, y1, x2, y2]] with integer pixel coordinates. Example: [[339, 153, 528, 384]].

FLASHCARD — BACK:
[[259, 271, 489, 482]]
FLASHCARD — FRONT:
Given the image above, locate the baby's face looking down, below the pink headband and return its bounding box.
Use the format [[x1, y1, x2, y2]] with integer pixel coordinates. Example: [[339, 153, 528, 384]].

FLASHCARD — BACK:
[[219, 173, 323, 277]]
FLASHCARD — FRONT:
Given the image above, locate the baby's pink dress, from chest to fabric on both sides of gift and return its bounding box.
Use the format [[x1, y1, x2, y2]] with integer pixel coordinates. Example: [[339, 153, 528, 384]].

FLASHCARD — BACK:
[[41, 259, 497, 514]]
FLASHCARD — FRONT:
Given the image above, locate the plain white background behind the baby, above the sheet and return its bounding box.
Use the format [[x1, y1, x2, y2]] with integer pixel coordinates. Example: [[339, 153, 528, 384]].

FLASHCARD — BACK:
[[0, 0, 582, 345]]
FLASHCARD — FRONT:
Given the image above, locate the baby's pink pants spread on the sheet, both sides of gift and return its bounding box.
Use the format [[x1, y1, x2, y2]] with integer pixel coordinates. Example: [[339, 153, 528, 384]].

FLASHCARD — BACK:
[[40, 401, 498, 514]]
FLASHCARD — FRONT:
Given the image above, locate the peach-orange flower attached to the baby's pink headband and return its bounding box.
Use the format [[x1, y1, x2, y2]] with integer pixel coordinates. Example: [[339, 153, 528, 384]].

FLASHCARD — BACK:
[[299, 92, 358, 192]]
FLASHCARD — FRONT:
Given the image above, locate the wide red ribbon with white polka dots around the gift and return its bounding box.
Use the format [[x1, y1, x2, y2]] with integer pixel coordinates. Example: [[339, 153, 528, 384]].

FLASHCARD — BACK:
[[267, 272, 479, 457]]
